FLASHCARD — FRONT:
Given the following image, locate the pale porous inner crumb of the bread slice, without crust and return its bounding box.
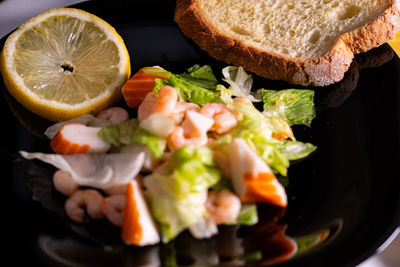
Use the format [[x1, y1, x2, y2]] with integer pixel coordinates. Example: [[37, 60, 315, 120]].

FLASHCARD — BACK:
[[199, 0, 390, 59]]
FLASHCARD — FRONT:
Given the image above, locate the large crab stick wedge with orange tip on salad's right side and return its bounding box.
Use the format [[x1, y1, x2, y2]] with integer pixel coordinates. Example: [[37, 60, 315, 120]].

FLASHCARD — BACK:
[[228, 138, 287, 207]]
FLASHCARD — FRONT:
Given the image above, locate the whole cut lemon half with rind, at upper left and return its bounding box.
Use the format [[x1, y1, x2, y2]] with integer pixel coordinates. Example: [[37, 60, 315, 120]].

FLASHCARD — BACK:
[[0, 8, 131, 121]]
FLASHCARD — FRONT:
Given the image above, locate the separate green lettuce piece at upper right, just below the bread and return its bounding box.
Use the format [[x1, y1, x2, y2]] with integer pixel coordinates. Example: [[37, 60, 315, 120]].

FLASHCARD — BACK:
[[260, 89, 316, 126]]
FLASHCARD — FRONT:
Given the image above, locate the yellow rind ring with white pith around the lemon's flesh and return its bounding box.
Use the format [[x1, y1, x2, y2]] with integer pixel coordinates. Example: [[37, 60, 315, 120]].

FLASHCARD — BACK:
[[0, 8, 131, 121]]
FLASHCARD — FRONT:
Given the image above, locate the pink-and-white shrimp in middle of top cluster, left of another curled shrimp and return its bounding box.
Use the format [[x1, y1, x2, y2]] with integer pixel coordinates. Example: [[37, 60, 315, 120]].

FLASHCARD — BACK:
[[167, 110, 214, 150]]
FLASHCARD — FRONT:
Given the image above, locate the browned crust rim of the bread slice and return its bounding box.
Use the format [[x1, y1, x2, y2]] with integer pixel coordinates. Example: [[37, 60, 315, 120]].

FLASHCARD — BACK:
[[174, 0, 400, 86]]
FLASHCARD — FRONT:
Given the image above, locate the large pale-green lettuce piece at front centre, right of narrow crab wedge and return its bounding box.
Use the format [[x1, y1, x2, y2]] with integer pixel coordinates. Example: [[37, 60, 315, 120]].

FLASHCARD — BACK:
[[144, 147, 221, 242]]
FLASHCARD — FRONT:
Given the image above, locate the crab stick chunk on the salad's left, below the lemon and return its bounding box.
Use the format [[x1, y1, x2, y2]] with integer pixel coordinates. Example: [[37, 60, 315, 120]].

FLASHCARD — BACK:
[[50, 123, 111, 155]]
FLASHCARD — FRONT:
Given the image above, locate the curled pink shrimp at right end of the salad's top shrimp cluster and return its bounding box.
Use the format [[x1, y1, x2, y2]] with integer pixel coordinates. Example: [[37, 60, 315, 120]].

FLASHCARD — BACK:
[[200, 103, 237, 134]]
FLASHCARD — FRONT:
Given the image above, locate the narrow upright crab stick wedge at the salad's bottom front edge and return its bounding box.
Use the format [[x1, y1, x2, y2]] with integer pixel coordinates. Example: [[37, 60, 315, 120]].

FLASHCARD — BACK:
[[122, 180, 160, 246]]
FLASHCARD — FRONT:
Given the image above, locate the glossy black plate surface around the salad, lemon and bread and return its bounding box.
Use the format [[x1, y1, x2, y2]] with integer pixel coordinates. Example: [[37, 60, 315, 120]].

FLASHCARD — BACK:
[[0, 1, 400, 266]]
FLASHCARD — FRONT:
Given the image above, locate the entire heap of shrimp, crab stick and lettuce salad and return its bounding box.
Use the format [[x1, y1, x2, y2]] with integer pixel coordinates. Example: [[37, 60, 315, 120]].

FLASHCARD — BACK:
[[20, 65, 316, 246]]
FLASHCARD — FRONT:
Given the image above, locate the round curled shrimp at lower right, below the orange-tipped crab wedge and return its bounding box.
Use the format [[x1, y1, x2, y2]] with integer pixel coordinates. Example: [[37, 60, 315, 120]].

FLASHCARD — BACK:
[[206, 190, 241, 224]]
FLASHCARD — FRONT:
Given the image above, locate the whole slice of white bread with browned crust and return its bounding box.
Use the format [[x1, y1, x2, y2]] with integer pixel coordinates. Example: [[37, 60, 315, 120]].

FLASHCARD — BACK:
[[174, 0, 400, 86]]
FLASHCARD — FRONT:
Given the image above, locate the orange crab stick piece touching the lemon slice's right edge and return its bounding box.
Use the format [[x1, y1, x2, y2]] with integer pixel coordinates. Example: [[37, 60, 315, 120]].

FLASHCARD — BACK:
[[122, 67, 171, 108]]
